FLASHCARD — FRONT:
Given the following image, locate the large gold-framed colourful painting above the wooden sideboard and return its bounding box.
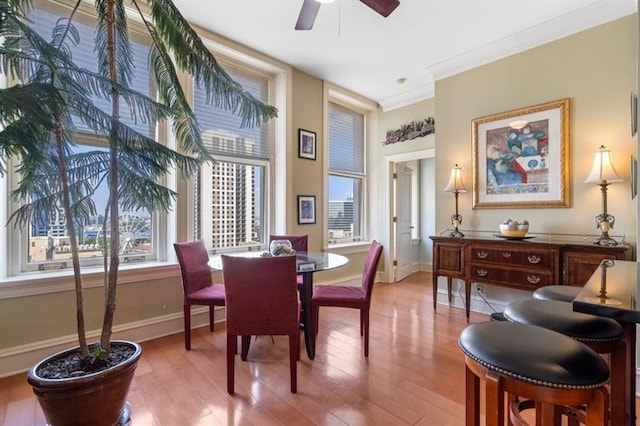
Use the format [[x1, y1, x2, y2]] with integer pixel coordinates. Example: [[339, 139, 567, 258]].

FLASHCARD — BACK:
[[471, 99, 569, 209]]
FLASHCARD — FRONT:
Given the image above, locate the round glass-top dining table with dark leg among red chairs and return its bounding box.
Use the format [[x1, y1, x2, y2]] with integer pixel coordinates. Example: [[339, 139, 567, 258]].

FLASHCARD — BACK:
[[209, 251, 349, 359]]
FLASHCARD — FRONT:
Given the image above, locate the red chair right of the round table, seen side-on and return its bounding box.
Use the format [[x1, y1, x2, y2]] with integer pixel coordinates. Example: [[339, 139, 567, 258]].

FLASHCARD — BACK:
[[311, 241, 382, 356]]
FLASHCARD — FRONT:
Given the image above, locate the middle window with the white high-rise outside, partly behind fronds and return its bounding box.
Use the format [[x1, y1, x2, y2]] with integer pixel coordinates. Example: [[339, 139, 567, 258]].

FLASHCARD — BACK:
[[194, 67, 272, 250]]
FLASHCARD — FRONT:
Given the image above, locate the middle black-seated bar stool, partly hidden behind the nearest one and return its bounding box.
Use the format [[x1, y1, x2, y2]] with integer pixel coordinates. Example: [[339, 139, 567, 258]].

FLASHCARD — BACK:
[[504, 298, 626, 425]]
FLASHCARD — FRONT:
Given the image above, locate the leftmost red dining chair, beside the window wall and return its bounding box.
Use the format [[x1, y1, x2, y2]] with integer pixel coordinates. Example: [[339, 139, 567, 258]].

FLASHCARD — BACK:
[[173, 240, 225, 350]]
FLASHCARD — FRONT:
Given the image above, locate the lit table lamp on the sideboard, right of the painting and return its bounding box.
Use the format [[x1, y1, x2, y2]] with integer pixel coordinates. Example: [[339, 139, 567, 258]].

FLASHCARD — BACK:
[[584, 145, 622, 246]]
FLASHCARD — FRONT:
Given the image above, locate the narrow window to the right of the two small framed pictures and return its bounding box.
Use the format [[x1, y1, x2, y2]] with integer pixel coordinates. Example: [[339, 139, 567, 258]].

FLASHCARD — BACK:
[[327, 103, 365, 243]]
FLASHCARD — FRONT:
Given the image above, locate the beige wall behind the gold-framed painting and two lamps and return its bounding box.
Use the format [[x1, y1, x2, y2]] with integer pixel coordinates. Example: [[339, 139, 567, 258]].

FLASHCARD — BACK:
[[435, 15, 637, 250]]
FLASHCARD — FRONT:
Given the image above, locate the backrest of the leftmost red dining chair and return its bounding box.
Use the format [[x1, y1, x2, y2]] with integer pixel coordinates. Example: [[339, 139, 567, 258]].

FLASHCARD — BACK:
[[173, 240, 213, 297]]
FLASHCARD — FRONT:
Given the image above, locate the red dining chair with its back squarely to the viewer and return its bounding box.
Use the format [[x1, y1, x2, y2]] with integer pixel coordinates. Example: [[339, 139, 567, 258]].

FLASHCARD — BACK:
[[221, 255, 300, 394]]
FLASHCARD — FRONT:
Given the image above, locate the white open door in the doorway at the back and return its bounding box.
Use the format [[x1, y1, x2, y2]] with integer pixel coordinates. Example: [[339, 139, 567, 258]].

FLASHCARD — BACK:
[[394, 163, 413, 282]]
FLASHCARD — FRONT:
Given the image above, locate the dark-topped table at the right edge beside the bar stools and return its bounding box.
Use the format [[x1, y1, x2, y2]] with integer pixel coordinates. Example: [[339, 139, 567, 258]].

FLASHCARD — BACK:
[[573, 260, 640, 426]]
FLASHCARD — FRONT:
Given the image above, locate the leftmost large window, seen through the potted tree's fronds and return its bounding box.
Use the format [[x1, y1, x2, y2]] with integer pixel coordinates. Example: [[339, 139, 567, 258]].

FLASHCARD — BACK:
[[13, 3, 157, 272]]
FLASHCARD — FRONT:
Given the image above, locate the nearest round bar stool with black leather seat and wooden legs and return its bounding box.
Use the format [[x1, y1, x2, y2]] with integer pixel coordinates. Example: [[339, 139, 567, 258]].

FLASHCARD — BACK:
[[458, 321, 609, 426]]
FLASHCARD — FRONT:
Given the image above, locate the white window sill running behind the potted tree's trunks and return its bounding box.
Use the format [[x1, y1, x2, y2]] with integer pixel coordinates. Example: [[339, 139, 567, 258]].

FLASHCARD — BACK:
[[0, 262, 180, 299]]
